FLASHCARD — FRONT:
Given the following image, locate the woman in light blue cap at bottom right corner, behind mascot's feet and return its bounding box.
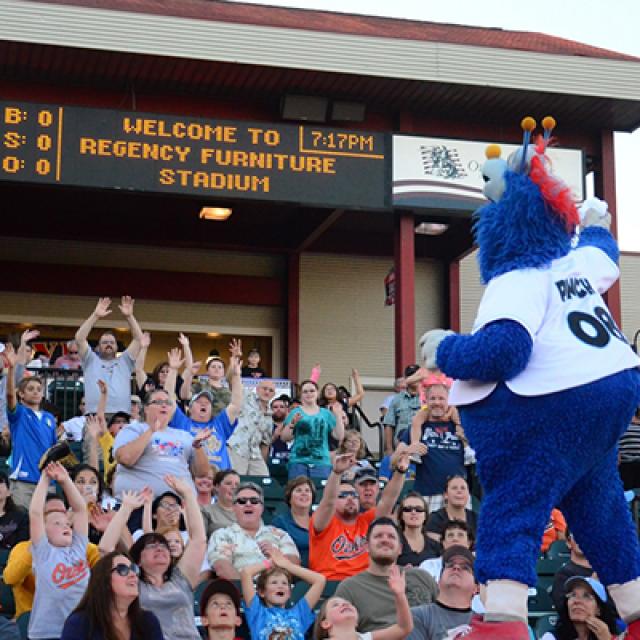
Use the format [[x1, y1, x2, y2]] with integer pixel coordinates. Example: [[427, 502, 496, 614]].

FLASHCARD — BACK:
[[541, 576, 620, 640]]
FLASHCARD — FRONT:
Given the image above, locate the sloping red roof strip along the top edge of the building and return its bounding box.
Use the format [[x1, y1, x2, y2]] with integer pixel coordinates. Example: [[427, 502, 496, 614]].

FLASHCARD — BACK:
[[33, 0, 640, 62]]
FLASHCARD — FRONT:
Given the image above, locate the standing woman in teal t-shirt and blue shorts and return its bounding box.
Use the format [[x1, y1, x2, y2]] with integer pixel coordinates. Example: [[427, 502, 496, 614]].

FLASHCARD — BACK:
[[285, 380, 344, 479]]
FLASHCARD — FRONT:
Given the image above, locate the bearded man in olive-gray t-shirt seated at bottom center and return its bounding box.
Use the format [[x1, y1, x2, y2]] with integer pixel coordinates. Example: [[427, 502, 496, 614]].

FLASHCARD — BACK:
[[336, 518, 438, 633]]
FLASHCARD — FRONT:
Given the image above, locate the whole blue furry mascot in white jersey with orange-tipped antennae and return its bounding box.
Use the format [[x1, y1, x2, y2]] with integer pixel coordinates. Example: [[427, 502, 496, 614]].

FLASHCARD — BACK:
[[423, 117, 640, 640]]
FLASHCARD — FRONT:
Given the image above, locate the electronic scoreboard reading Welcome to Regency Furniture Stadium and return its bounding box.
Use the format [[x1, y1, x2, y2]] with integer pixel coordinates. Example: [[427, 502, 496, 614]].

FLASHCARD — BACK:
[[0, 102, 390, 209]]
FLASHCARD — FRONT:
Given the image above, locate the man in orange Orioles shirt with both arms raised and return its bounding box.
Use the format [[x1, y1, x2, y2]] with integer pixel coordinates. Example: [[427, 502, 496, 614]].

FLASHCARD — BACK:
[[309, 443, 424, 580]]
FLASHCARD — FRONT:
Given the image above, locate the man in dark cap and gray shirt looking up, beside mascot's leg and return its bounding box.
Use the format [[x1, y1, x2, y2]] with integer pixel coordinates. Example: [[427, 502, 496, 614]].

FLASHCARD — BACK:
[[408, 546, 478, 640]]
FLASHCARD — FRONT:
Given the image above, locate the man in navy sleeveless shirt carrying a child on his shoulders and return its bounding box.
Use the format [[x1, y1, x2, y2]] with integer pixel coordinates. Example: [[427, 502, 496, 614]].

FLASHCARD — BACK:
[[411, 384, 467, 511]]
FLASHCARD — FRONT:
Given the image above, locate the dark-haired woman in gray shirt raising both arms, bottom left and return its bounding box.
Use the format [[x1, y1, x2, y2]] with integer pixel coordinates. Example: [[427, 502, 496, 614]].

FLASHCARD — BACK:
[[100, 476, 206, 640]]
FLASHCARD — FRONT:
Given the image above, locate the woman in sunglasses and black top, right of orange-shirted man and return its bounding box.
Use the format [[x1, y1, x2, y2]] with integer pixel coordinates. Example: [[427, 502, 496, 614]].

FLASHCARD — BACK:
[[398, 491, 440, 567]]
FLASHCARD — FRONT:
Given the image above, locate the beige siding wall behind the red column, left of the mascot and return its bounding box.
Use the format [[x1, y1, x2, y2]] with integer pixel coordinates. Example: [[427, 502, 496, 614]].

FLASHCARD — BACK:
[[300, 254, 444, 388]]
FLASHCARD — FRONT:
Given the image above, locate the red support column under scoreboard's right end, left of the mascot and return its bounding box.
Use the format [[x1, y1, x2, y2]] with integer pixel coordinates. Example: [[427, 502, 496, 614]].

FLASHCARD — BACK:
[[394, 213, 416, 376]]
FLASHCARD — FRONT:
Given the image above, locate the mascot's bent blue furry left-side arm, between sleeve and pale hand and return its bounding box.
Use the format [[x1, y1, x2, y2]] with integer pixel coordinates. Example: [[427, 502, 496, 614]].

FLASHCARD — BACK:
[[437, 320, 533, 382]]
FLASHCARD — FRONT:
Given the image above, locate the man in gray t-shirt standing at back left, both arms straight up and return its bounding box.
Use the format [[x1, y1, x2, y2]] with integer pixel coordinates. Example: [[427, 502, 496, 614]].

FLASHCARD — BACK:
[[76, 296, 142, 414]]
